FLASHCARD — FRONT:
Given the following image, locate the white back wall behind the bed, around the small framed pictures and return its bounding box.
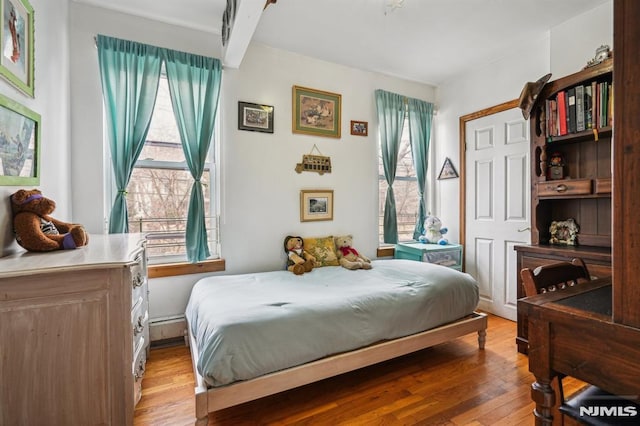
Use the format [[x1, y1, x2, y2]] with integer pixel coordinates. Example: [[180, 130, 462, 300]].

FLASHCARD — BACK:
[[70, 3, 435, 318]]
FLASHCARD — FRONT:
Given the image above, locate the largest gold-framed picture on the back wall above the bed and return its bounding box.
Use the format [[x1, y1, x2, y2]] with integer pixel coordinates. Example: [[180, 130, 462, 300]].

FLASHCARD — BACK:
[[293, 86, 342, 138]]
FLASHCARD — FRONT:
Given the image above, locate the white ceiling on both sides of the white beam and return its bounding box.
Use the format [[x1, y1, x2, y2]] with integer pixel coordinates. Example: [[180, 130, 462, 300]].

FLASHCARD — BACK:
[[75, 0, 609, 85]]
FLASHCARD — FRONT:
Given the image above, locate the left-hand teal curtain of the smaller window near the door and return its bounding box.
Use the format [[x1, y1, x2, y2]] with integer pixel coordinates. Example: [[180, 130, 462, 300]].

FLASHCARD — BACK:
[[375, 89, 405, 244]]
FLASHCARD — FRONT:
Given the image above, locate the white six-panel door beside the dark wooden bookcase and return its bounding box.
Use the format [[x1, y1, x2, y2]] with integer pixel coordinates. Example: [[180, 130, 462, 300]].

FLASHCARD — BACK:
[[465, 108, 531, 320]]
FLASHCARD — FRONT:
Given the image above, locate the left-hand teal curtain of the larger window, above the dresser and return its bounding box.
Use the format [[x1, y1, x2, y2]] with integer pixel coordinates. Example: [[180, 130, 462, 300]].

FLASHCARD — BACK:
[[96, 35, 162, 234]]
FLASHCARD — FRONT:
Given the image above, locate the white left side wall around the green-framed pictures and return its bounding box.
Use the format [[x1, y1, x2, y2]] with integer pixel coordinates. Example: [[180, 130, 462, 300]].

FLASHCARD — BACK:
[[0, 0, 73, 256]]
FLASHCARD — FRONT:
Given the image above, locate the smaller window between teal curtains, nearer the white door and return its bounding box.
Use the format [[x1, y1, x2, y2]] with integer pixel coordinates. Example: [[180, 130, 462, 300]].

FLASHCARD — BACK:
[[378, 117, 419, 244]]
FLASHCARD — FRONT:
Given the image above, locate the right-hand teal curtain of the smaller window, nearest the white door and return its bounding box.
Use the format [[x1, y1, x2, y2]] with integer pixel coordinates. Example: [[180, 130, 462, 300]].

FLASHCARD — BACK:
[[407, 98, 433, 240]]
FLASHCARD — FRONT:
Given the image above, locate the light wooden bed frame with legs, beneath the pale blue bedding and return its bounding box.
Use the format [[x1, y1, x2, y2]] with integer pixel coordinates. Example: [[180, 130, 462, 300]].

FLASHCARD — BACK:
[[187, 312, 487, 426]]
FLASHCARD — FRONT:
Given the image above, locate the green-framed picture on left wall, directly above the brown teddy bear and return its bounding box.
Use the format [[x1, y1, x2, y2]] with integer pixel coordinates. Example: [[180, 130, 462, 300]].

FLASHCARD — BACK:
[[0, 91, 40, 186]]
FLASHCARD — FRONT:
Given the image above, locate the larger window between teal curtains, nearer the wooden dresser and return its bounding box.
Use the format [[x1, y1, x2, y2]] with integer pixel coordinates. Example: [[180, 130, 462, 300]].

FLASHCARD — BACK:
[[127, 72, 218, 263]]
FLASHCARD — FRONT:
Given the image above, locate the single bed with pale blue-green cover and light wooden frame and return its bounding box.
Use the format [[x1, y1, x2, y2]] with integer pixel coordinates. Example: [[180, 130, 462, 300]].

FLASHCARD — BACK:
[[186, 259, 487, 425]]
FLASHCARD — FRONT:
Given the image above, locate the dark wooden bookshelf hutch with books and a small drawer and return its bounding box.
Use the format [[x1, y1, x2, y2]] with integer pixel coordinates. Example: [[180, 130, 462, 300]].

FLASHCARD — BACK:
[[530, 59, 613, 250]]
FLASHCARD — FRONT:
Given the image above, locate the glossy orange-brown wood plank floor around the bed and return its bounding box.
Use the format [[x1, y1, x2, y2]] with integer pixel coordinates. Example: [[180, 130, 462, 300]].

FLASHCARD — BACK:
[[134, 315, 581, 426]]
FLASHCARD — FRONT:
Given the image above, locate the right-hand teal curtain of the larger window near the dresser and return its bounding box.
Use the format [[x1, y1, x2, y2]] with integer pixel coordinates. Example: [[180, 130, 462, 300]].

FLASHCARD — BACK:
[[163, 49, 222, 263]]
